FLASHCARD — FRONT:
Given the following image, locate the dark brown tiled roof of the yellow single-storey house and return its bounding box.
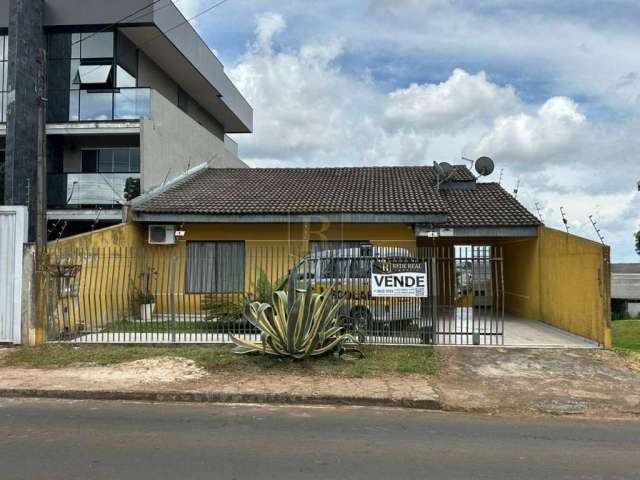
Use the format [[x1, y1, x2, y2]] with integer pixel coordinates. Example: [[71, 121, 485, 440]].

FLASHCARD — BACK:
[[134, 165, 538, 226]]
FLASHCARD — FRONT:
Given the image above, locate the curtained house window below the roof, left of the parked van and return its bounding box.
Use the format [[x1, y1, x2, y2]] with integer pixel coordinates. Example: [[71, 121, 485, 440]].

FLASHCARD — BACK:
[[186, 242, 244, 293]]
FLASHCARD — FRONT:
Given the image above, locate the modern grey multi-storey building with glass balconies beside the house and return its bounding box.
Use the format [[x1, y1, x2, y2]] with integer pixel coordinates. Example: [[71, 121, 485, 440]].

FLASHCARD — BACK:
[[0, 0, 253, 240]]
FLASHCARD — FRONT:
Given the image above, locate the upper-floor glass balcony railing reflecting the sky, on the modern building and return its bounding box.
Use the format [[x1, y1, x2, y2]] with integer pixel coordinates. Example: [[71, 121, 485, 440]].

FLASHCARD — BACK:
[[47, 88, 151, 122]]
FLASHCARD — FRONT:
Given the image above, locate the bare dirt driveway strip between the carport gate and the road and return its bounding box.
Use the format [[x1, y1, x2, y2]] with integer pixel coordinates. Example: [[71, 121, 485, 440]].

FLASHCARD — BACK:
[[434, 348, 640, 417]]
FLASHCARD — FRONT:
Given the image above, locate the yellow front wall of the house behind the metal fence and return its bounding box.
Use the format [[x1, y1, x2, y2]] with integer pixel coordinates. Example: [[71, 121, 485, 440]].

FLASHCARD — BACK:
[[43, 223, 415, 332]]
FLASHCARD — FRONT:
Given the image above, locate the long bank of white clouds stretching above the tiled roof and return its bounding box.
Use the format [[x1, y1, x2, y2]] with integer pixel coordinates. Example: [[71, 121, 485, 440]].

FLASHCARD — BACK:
[[227, 13, 640, 260]]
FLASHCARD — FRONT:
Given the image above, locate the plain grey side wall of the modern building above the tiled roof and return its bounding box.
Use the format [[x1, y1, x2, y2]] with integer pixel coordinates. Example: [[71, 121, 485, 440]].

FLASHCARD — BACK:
[[140, 90, 247, 191]]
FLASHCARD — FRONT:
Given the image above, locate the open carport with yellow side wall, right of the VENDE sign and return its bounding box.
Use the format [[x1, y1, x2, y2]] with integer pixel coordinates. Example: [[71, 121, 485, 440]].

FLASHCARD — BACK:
[[416, 223, 611, 348]]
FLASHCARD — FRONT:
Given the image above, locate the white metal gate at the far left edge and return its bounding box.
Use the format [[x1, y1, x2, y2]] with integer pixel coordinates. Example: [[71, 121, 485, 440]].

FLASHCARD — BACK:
[[0, 206, 27, 343]]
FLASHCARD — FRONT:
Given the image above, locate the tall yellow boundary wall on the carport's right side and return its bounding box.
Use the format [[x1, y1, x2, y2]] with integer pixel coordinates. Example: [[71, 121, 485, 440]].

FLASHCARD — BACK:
[[503, 227, 611, 348]]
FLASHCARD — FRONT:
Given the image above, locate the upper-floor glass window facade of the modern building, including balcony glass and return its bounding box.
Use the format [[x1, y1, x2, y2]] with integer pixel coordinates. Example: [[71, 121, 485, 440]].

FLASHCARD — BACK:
[[47, 32, 150, 122]]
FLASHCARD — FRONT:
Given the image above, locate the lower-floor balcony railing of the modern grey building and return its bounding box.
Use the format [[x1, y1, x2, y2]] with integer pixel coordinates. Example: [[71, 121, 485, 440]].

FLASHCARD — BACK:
[[47, 173, 140, 208]]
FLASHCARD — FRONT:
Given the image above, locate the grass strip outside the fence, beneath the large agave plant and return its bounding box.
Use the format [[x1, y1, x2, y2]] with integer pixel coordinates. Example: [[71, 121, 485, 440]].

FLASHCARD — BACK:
[[3, 345, 440, 377]]
